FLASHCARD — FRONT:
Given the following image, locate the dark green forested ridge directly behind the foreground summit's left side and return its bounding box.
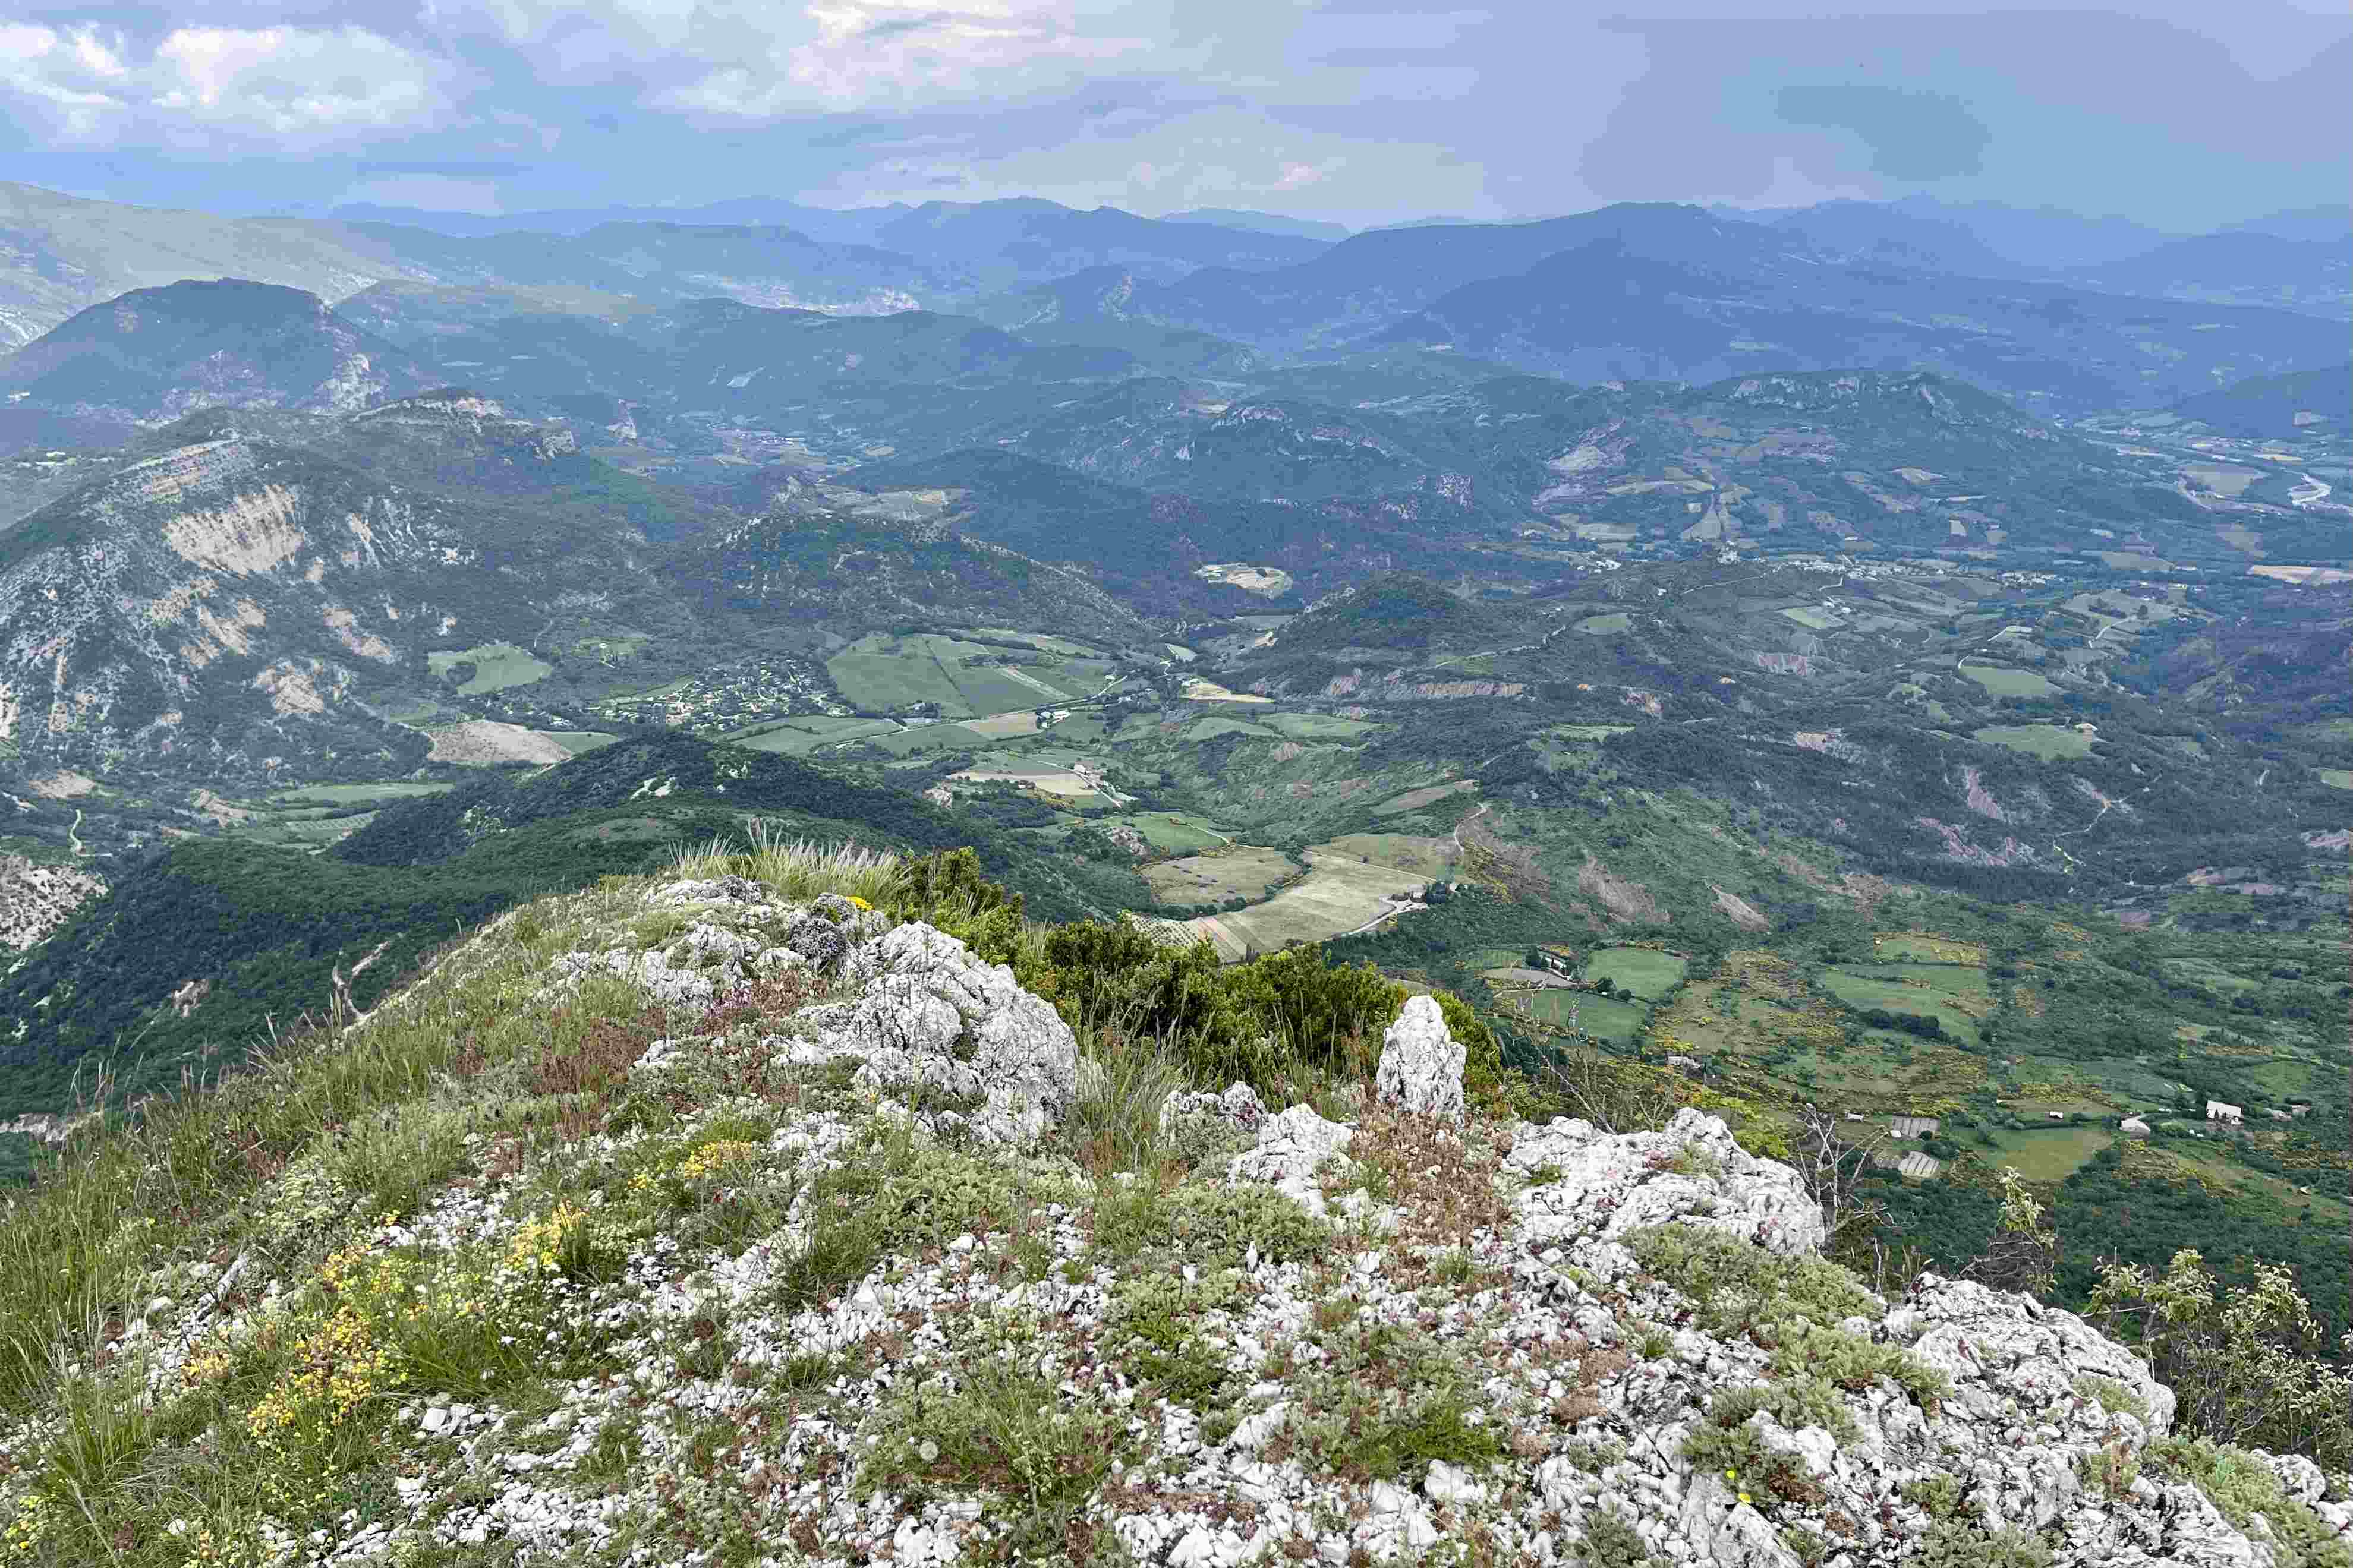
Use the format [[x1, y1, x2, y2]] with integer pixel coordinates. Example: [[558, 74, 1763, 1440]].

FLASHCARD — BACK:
[[0, 736, 1101, 1119]]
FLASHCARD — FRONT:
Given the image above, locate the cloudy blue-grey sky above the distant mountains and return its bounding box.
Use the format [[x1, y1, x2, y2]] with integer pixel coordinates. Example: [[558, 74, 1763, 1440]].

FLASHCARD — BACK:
[[0, 0, 2353, 233]]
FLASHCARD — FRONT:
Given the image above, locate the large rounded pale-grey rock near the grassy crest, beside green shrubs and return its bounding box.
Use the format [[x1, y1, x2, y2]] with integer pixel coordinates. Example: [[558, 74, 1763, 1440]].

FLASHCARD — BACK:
[[779, 917, 1078, 1145]]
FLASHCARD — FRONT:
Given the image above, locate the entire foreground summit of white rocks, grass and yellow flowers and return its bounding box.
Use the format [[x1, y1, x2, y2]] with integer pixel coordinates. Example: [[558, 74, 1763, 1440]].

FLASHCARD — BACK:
[[0, 851, 2353, 1568]]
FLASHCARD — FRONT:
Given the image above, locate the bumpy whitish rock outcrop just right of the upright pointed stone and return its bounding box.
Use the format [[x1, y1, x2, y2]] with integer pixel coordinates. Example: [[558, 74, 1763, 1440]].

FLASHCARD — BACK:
[[1506, 1109, 1826, 1255]]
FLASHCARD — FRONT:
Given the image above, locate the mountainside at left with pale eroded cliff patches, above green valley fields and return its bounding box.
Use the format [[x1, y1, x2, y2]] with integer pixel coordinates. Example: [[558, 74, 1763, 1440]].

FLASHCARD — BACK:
[[0, 435, 482, 778]]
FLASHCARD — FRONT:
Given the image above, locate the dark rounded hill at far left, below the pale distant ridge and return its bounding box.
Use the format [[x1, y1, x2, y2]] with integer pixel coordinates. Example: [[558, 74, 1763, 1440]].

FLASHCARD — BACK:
[[0, 280, 430, 428]]
